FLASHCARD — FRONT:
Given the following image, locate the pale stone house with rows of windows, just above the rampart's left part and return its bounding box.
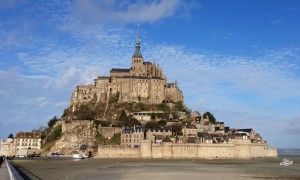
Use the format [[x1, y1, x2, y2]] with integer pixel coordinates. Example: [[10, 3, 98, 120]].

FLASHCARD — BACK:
[[121, 126, 145, 148]]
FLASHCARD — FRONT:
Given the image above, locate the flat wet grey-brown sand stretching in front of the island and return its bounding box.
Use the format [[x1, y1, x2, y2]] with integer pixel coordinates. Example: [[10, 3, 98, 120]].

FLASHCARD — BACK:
[[14, 157, 300, 180]]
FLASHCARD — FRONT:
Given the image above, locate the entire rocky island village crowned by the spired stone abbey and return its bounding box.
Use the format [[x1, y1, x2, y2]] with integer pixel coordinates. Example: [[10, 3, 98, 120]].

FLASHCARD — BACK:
[[1, 34, 277, 159]]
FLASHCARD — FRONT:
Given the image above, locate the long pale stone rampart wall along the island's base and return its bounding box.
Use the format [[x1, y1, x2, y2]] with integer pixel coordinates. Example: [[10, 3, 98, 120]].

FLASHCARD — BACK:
[[95, 140, 278, 159]]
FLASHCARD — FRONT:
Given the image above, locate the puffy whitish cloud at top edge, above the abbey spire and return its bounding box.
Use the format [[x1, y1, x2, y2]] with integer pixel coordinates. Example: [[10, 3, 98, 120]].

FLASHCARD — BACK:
[[72, 0, 201, 25]]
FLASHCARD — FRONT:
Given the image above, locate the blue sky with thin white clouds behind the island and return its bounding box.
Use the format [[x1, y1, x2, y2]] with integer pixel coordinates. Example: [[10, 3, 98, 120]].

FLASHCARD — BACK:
[[0, 0, 300, 148]]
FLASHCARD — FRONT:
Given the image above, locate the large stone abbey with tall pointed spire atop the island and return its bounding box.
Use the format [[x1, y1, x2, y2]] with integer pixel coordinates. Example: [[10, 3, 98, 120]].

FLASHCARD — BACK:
[[71, 34, 184, 111]]
